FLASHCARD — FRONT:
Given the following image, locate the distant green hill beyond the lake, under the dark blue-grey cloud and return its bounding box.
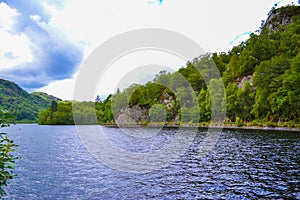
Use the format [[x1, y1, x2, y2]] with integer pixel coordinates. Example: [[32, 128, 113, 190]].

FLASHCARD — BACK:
[[0, 79, 61, 123]]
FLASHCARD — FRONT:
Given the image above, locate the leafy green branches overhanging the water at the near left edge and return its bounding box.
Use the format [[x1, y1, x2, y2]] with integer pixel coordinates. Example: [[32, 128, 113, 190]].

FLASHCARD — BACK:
[[0, 110, 17, 196]]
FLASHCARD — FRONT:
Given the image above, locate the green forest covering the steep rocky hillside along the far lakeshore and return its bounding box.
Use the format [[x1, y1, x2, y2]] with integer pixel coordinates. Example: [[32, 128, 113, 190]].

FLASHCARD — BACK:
[[39, 6, 300, 128]]
